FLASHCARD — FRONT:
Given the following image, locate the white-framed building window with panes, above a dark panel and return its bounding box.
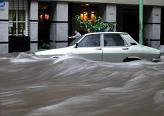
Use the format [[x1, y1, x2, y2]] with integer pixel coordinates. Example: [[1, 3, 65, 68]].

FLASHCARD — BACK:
[[9, 0, 28, 35]]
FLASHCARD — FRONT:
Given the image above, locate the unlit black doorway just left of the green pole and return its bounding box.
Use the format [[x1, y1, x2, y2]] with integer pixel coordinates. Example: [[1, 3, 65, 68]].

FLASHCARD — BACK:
[[117, 6, 139, 41]]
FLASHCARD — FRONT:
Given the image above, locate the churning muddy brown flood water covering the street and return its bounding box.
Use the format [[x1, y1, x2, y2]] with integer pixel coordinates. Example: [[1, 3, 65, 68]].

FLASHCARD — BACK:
[[0, 53, 164, 116]]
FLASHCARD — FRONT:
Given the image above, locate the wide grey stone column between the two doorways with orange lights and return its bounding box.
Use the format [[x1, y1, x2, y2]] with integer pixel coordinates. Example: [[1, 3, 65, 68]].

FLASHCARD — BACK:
[[50, 2, 68, 48]]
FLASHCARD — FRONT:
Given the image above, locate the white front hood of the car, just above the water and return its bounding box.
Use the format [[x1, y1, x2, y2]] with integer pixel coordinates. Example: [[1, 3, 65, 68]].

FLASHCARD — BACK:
[[35, 46, 73, 56]]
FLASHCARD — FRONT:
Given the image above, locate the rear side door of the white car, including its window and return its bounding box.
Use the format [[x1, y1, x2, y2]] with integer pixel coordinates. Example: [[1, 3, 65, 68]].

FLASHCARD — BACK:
[[102, 33, 129, 62]]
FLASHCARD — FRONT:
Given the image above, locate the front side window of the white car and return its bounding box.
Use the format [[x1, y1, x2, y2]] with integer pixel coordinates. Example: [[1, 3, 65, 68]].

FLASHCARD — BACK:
[[78, 34, 100, 47]]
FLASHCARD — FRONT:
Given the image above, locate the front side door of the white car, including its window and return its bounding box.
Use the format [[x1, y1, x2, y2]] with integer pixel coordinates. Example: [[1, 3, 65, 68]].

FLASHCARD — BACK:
[[74, 34, 102, 61]]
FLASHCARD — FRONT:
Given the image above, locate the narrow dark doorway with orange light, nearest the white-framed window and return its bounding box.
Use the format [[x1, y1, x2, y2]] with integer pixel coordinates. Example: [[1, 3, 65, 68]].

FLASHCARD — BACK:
[[38, 2, 50, 49]]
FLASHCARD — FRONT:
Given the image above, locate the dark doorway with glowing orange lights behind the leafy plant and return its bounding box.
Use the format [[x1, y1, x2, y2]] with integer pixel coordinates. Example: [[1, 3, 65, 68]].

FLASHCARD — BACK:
[[68, 3, 102, 43]]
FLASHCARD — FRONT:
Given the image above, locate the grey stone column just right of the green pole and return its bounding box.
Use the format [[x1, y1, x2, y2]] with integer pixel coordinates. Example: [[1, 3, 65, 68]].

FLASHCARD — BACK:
[[144, 7, 161, 49]]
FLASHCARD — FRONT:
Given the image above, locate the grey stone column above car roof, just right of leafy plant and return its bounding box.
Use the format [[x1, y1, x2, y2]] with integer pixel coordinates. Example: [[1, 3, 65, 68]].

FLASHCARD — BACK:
[[103, 4, 116, 31]]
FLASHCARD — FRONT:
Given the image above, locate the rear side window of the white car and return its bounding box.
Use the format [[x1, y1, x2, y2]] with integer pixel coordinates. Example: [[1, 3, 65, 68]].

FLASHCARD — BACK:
[[104, 34, 125, 46]]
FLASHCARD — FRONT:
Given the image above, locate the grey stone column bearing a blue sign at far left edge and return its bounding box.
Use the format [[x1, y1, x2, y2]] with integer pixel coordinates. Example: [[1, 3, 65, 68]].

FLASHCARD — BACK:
[[0, 0, 9, 54]]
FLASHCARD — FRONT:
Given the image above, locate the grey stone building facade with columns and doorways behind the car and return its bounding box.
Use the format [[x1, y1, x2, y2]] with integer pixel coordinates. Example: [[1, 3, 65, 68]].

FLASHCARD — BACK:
[[0, 0, 164, 54]]
